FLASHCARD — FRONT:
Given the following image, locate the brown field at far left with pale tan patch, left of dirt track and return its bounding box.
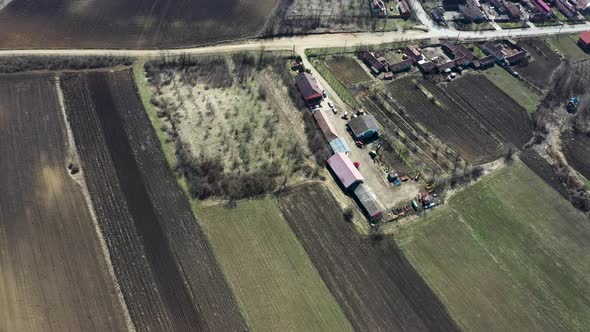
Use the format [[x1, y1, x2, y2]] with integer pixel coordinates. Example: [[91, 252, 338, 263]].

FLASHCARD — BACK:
[[0, 75, 127, 331]]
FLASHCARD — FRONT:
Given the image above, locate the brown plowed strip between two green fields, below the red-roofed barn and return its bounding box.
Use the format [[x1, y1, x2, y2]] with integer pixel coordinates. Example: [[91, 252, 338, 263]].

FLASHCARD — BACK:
[[279, 184, 458, 331]]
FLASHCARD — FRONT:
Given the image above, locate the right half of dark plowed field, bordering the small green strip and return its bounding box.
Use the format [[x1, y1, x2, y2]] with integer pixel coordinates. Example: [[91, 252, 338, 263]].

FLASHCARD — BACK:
[[446, 75, 533, 148]]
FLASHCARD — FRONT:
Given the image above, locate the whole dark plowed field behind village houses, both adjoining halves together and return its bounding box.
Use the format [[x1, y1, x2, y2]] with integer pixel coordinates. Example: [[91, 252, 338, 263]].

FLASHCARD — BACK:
[[389, 75, 532, 163]]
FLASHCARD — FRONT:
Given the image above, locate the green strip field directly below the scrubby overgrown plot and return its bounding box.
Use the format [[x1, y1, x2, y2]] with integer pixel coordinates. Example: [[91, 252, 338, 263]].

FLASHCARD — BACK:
[[197, 198, 352, 331]]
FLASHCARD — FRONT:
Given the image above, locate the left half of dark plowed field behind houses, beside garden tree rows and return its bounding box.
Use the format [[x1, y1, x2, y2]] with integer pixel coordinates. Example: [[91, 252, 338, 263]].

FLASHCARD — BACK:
[[388, 77, 502, 163]]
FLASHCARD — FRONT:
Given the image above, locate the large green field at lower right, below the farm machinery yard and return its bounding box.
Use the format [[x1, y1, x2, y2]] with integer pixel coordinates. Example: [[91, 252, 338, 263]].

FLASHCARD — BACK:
[[396, 162, 590, 331]]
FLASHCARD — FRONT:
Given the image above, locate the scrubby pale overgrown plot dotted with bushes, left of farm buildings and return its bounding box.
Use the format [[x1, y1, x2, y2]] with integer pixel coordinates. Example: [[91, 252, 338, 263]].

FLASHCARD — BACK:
[[145, 53, 327, 199]]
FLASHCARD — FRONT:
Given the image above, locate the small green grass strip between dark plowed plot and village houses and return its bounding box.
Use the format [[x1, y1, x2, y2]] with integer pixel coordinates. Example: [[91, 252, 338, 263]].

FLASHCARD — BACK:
[[483, 66, 542, 113]]
